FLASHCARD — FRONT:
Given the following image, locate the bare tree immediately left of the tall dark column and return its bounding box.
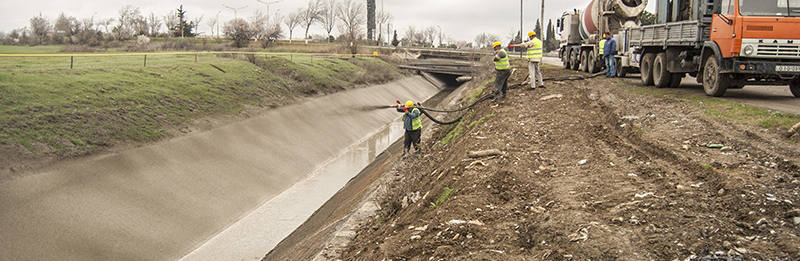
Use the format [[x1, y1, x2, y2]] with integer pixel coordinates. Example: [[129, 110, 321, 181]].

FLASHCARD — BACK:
[[336, 0, 367, 54]]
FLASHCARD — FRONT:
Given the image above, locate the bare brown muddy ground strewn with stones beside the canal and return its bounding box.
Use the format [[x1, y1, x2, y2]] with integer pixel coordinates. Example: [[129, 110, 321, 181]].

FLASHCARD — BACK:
[[330, 64, 800, 260]]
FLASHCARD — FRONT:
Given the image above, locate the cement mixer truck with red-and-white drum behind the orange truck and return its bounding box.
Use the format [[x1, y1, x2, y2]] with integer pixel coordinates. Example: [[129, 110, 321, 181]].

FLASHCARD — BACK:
[[556, 0, 647, 73]]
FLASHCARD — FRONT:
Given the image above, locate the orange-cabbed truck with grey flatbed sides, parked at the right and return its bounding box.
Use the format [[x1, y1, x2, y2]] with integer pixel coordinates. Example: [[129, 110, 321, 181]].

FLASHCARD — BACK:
[[615, 0, 800, 97]]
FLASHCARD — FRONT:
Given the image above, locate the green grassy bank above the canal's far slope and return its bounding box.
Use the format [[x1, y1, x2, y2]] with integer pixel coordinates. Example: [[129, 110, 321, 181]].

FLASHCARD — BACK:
[[0, 46, 401, 155]]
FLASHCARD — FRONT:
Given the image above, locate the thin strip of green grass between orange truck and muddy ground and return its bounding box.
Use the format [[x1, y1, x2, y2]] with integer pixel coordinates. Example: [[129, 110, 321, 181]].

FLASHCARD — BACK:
[[629, 88, 800, 128]]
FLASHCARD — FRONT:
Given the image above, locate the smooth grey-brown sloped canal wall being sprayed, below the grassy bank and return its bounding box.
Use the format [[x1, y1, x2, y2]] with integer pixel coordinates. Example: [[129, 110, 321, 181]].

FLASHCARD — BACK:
[[0, 77, 438, 260]]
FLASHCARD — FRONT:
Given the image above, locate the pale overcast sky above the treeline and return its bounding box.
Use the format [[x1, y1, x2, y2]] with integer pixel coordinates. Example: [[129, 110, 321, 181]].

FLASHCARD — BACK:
[[0, 0, 655, 42]]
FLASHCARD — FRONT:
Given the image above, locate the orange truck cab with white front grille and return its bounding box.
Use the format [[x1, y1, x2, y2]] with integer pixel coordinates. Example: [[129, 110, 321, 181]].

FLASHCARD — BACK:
[[703, 0, 800, 97]]
